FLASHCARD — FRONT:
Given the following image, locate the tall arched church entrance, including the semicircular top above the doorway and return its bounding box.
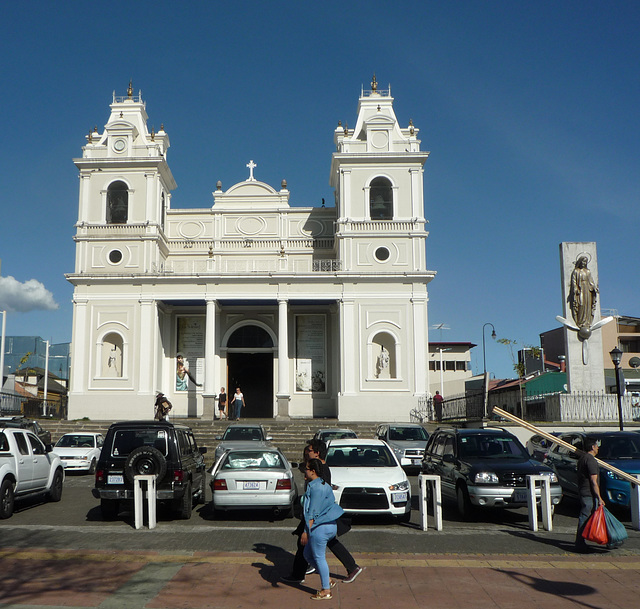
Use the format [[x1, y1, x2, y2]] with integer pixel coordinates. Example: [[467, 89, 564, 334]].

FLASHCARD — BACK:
[[227, 325, 274, 419]]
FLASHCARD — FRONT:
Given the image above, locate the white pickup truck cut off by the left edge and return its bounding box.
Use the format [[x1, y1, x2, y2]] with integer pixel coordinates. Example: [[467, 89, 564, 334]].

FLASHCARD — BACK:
[[0, 427, 64, 518]]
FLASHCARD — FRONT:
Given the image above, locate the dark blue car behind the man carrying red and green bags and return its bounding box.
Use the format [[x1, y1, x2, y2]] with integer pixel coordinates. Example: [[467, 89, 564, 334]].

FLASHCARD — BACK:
[[544, 431, 640, 508]]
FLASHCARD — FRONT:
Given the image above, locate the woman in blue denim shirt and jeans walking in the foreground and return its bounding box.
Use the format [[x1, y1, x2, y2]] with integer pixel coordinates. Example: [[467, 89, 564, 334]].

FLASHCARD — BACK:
[[300, 459, 344, 601]]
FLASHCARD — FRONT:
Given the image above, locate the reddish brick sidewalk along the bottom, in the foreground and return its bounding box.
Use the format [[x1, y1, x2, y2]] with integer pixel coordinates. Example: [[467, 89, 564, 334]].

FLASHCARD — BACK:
[[0, 545, 640, 609]]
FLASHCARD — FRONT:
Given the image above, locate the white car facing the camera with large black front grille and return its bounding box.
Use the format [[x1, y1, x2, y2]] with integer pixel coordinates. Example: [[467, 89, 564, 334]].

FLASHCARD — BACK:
[[327, 439, 411, 522]]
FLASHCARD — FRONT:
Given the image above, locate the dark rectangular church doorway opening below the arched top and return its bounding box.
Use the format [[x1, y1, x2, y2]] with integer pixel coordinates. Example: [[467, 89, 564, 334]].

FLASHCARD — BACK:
[[227, 353, 274, 419]]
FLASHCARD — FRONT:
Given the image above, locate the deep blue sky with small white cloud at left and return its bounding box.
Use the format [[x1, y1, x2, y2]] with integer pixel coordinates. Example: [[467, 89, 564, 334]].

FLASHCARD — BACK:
[[0, 0, 640, 377]]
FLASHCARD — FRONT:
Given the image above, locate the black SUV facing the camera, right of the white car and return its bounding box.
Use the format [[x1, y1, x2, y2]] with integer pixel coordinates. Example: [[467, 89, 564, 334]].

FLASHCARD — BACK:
[[422, 428, 562, 518]]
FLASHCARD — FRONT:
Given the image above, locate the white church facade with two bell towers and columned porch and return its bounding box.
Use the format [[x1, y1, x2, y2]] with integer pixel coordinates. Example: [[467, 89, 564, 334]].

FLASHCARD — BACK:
[[67, 79, 435, 421]]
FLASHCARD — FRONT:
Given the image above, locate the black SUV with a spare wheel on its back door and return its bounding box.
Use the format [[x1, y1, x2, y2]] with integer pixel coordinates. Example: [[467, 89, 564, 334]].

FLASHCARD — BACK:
[[92, 421, 207, 520]]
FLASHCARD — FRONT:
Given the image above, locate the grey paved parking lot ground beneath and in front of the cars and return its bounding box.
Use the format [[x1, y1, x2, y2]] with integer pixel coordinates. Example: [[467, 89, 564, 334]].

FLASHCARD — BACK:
[[0, 474, 640, 554]]
